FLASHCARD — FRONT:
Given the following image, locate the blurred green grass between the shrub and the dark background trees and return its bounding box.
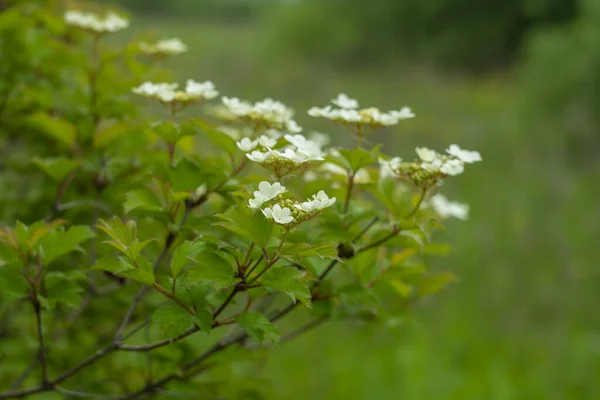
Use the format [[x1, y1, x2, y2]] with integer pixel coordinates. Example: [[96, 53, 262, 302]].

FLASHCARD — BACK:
[[127, 19, 600, 400]]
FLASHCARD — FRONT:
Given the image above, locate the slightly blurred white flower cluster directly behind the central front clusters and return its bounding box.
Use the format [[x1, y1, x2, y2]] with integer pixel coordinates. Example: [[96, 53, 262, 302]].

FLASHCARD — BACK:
[[222, 97, 302, 133]]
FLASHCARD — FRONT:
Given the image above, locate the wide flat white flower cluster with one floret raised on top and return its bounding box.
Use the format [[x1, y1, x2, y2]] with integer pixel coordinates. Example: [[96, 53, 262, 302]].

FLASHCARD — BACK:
[[308, 93, 415, 126]]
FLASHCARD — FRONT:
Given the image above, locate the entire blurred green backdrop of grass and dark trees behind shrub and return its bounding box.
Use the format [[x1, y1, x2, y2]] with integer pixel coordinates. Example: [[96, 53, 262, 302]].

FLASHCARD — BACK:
[[106, 0, 600, 400]]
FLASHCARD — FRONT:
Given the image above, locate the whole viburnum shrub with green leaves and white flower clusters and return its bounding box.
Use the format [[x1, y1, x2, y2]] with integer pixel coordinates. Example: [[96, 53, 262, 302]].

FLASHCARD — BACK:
[[0, 1, 481, 399]]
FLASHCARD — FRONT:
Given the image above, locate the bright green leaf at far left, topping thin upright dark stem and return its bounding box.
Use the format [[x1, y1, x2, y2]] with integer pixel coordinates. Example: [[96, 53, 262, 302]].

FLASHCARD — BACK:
[[38, 226, 96, 265]]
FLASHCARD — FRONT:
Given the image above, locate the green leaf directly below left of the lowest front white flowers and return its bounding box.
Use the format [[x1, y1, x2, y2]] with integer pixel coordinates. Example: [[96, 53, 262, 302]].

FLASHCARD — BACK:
[[214, 206, 273, 248]]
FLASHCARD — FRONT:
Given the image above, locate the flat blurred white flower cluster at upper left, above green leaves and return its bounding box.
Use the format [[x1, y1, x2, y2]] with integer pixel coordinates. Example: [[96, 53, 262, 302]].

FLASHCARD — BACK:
[[133, 79, 219, 103]]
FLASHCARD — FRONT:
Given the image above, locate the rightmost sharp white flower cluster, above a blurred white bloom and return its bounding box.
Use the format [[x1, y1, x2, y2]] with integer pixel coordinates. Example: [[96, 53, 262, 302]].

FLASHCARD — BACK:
[[416, 144, 481, 176]]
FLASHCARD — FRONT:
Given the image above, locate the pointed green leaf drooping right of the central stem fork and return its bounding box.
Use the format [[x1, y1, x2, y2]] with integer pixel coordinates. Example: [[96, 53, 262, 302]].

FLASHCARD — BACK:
[[260, 266, 312, 307]]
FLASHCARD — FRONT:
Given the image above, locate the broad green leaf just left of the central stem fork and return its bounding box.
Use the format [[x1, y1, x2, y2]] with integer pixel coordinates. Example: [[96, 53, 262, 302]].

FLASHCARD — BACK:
[[187, 251, 239, 290]]
